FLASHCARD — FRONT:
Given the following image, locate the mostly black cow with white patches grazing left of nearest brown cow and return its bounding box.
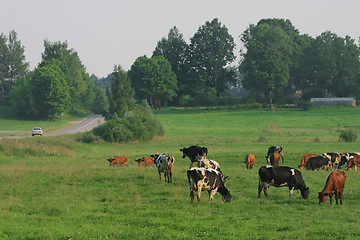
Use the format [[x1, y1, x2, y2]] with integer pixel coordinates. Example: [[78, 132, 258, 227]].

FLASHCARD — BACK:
[[258, 166, 310, 199]]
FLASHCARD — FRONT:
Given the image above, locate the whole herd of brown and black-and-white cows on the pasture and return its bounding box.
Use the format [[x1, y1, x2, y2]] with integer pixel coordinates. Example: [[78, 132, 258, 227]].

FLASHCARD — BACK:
[[107, 146, 360, 204]]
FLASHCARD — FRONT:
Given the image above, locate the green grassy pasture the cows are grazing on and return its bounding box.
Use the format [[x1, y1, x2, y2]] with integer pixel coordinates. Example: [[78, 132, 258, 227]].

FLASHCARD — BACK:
[[0, 107, 360, 239]]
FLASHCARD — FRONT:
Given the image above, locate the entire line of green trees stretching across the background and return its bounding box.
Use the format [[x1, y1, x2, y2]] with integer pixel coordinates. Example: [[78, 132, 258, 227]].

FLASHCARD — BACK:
[[0, 18, 360, 118]]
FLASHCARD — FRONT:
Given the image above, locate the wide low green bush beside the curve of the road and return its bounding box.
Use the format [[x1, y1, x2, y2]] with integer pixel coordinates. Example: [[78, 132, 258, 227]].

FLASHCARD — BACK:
[[92, 105, 164, 142]]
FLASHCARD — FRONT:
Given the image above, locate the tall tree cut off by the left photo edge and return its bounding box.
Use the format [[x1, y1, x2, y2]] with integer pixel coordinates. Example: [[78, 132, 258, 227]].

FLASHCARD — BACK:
[[0, 31, 29, 104]]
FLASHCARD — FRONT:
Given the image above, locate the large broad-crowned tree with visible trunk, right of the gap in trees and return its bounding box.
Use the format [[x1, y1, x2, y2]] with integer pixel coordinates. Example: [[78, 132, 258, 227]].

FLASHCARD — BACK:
[[240, 23, 293, 108]]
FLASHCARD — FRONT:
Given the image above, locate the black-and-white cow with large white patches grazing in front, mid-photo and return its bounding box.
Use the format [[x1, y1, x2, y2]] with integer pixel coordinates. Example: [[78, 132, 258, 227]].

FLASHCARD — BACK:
[[187, 168, 231, 203]]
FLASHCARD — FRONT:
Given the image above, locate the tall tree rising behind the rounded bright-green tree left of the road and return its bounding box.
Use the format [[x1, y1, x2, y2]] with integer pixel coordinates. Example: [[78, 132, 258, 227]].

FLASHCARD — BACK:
[[42, 40, 97, 110]]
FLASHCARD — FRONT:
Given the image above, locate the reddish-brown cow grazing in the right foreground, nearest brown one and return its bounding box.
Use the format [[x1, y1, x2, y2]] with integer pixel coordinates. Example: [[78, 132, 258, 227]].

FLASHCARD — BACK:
[[319, 171, 346, 204]]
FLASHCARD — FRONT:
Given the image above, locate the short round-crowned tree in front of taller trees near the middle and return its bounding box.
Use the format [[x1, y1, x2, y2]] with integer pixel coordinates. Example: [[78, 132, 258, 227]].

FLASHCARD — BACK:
[[129, 56, 178, 110]]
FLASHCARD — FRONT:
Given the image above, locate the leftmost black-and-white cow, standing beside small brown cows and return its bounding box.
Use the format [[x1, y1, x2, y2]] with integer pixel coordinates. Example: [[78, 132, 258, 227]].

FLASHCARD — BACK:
[[152, 154, 175, 183]]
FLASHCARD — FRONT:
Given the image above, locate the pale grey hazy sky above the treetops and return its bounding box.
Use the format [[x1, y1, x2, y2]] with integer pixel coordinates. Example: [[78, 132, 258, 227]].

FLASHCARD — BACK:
[[0, 0, 360, 77]]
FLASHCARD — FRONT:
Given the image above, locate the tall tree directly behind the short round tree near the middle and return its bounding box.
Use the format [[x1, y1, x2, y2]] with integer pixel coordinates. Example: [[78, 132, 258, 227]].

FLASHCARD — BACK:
[[152, 27, 191, 102]]
